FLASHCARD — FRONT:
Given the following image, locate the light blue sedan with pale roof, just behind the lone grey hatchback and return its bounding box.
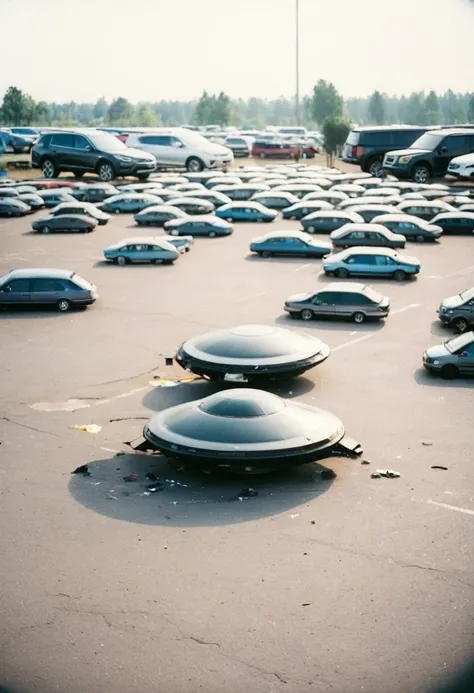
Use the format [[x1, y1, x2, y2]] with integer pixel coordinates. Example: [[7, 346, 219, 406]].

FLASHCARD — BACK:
[[323, 247, 421, 281]]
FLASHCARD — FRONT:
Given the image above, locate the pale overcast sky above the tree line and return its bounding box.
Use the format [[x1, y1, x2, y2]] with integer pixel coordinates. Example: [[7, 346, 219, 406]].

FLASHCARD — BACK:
[[0, 0, 474, 102]]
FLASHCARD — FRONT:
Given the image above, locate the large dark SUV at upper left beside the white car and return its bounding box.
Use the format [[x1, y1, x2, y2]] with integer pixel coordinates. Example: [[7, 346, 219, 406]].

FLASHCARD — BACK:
[[31, 130, 156, 181]]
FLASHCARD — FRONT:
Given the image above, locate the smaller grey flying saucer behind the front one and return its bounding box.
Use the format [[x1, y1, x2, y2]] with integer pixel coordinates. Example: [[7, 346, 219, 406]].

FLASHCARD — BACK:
[[175, 325, 331, 381]]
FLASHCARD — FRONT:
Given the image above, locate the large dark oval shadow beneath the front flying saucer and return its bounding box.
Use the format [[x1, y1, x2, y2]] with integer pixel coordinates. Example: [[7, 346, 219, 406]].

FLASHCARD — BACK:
[[69, 453, 336, 527]]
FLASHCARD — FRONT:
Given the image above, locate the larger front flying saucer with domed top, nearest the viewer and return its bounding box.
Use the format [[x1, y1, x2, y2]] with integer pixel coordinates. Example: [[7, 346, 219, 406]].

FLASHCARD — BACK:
[[141, 388, 361, 471]]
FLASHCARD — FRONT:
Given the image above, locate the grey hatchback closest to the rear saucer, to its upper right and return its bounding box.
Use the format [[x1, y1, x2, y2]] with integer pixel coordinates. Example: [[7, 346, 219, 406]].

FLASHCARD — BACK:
[[284, 282, 390, 324]]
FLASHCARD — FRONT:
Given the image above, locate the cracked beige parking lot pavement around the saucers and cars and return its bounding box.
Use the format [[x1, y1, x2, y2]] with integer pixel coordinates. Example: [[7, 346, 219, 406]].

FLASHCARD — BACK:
[[0, 195, 474, 693]]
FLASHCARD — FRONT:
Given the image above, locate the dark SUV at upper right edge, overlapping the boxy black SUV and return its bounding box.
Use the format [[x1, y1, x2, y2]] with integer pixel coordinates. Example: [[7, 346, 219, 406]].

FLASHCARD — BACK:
[[383, 127, 474, 183]]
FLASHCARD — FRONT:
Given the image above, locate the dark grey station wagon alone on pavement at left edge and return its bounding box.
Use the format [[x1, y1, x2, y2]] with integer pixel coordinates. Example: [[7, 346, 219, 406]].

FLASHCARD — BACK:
[[0, 269, 98, 313]]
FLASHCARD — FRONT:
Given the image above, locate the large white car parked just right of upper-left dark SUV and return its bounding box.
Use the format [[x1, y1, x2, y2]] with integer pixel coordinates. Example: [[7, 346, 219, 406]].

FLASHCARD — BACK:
[[127, 128, 234, 172]]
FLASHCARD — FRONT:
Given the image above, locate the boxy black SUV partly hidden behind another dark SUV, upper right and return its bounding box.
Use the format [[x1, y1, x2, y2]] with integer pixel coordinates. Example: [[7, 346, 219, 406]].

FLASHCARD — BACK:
[[341, 125, 430, 176]]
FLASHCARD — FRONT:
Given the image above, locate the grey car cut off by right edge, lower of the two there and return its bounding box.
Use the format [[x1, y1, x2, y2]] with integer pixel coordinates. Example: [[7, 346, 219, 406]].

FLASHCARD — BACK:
[[423, 332, 474, 380]]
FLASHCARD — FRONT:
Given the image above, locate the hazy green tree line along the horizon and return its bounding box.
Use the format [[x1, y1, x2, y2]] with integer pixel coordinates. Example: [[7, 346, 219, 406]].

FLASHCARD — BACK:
[[0, 79, 474, 129]]
